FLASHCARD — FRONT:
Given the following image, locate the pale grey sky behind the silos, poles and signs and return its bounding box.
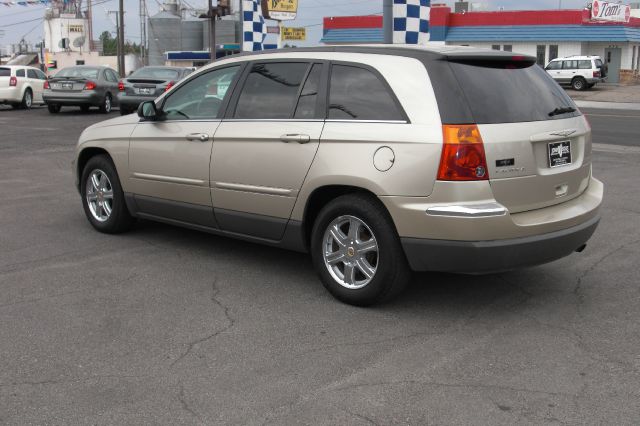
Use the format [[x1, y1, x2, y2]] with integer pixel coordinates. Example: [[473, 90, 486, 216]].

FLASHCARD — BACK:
[[0, 0, 592, 45]]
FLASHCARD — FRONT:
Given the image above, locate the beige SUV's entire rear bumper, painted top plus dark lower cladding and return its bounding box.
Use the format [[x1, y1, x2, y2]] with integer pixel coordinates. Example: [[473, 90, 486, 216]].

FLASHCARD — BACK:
[[382, 179, 603, 274]]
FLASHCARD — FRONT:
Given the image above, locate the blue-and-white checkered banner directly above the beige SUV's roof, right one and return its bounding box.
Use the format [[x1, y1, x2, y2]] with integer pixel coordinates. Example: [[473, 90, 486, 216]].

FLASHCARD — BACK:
[[393, 0, 431, 44]]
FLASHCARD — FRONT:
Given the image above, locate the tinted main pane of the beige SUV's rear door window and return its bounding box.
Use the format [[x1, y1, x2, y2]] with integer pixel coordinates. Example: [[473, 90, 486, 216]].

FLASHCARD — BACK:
[[234, 62, 309, 119]]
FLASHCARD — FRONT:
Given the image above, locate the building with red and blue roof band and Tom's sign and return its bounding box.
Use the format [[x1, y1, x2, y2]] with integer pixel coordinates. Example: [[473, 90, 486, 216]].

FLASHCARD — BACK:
[[321, 4, 640, 83]]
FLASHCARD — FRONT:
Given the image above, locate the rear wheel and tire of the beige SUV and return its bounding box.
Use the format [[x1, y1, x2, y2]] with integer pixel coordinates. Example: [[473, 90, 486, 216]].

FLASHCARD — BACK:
[[311, 194, 411, 306]]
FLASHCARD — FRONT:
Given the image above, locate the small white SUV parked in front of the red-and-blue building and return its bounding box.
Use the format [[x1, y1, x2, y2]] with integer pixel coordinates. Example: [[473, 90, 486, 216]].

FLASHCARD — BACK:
[[545, 56, 607, 90]]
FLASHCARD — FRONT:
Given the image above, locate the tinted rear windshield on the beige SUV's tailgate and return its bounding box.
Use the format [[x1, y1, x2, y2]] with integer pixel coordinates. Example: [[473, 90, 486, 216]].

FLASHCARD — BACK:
[[450, 62, 580, 124]]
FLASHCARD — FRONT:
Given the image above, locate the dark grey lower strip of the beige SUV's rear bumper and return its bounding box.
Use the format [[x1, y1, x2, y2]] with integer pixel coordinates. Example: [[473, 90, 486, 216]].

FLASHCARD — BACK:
[[401, 215, 600, 273]]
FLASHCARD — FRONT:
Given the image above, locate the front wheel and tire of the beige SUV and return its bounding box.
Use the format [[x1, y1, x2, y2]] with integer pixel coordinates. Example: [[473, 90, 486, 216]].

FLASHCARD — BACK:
[[80, 155, 133, 234]]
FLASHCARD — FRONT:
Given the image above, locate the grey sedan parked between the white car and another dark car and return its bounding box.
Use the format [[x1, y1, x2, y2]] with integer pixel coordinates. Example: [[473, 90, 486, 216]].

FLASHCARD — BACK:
[[42, 65, 118, 114]]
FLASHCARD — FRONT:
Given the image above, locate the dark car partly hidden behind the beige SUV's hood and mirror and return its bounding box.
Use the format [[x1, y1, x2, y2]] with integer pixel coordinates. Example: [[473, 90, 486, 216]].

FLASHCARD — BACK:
[[118, 67, 192, 115]]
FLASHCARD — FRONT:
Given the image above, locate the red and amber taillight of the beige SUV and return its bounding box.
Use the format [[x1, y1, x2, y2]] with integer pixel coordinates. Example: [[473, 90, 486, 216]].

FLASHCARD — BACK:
[[438, 124, 489, 181]]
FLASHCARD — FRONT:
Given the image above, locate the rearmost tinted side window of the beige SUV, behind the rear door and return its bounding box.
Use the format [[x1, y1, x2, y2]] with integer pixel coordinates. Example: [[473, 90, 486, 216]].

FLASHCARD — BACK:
[[328, 65, 405, 121]]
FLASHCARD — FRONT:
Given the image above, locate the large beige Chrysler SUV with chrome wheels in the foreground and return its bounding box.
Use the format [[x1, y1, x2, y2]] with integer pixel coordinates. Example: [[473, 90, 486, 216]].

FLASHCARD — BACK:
[[73, 46, 603, 305]]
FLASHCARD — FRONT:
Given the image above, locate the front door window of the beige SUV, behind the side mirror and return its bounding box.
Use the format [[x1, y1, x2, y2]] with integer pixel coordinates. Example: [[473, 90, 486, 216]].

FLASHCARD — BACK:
[[162, 66, 240, 120]]
